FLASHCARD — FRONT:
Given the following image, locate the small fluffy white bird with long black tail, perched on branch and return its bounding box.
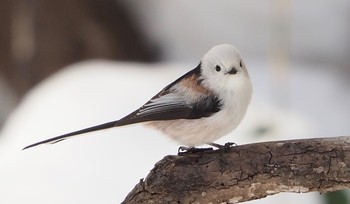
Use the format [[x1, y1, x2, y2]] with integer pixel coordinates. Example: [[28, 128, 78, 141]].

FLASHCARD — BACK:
[[23, 44, 252, 150]]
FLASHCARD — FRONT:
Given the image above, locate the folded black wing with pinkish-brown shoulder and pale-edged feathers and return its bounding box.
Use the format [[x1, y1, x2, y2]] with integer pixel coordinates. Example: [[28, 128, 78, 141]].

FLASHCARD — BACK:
[[116, 64, 222, 126]]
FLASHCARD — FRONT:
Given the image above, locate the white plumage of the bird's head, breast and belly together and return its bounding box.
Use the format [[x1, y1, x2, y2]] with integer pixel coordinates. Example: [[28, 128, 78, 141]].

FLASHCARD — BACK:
[[149, 45, 252, 146]]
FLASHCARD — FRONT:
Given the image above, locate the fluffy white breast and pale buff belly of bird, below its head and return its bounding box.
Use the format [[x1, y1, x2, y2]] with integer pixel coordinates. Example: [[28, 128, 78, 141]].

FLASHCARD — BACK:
[[147, 77, 252, 146]]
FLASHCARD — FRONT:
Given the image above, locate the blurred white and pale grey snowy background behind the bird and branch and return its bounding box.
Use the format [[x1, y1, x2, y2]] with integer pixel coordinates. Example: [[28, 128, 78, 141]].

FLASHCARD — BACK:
[[0, 0, 350, 204]]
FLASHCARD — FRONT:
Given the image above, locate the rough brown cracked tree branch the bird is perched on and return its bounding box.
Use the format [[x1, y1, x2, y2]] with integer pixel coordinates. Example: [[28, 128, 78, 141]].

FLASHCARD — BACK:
[[123, 136, 350, 203]]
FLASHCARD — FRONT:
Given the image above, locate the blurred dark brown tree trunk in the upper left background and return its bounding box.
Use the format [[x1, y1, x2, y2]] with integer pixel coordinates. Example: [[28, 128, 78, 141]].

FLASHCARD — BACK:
[[0, 0, 155, 95]]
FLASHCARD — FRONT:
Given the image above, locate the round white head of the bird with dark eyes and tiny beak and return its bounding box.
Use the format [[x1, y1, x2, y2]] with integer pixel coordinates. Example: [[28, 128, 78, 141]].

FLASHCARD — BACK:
[[201, 44, 251, 93]]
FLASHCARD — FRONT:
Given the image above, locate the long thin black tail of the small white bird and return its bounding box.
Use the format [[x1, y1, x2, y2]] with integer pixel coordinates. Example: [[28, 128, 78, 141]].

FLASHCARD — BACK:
[[23, 121, 118, 150]]
